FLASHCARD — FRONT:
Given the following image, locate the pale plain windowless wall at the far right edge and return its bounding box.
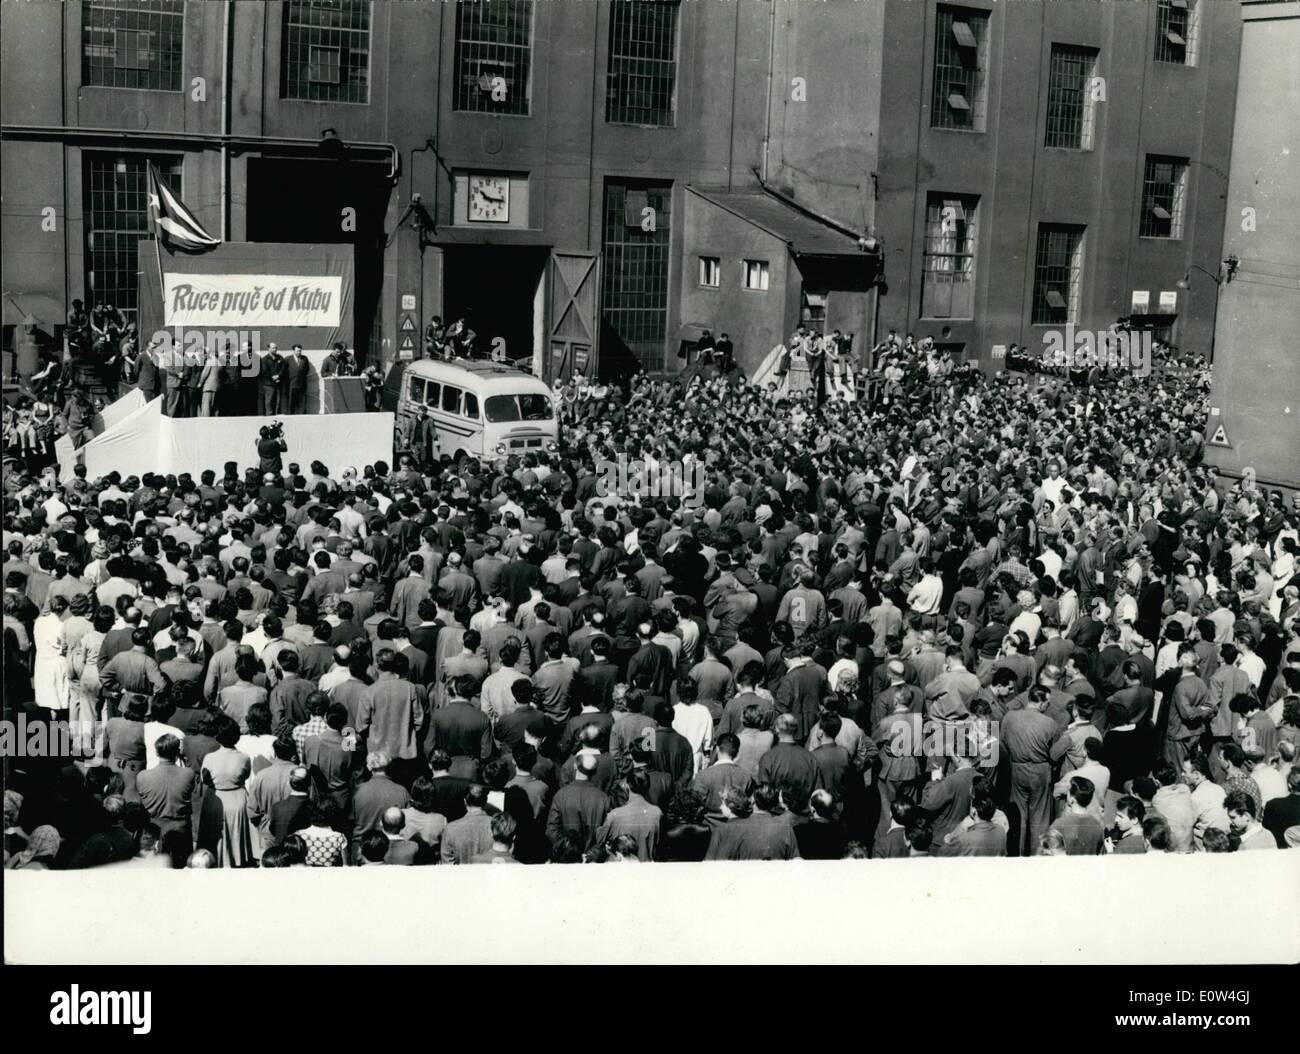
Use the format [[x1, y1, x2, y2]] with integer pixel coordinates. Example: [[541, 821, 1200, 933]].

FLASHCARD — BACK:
[[1193, 0, 1300, 487]]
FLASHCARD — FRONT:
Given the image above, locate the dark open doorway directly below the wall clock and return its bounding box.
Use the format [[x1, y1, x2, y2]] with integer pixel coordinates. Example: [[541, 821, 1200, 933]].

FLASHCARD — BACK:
[[442, 246, 550, 365]]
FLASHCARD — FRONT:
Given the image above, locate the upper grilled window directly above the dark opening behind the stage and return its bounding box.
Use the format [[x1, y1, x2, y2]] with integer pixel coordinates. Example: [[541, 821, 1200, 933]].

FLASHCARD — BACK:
[[280, 0, 371, 103]]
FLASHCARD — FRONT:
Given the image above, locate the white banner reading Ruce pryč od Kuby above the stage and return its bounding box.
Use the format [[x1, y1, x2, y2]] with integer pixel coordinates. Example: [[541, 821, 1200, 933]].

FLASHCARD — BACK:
[[163, 274, 343, 329]]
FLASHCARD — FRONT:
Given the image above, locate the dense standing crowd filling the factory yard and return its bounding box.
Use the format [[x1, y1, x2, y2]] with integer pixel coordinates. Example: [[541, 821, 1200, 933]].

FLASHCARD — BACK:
[[3, 327, 1300, 868]]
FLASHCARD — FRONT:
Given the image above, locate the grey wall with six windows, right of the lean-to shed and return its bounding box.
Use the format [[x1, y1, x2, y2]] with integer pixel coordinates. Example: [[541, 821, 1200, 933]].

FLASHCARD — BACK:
[[879, 0, 1238, 361]]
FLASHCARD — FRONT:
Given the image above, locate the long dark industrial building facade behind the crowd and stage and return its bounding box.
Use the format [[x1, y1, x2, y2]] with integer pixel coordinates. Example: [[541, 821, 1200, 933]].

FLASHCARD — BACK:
[[0, 0, 1240, 378]]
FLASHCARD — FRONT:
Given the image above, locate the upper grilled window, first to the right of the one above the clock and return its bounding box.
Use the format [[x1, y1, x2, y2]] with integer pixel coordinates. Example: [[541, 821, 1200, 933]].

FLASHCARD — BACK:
[[605, 0, 677, 126]]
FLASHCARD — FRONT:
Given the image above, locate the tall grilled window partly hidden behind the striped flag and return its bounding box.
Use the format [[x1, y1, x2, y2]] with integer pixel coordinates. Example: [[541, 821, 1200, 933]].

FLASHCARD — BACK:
[[82, 153, 182, 322]]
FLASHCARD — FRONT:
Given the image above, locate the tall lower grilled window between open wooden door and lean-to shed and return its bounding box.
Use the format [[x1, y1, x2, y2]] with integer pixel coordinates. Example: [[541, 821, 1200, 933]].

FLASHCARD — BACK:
[[602, 182, 672, 370]]
